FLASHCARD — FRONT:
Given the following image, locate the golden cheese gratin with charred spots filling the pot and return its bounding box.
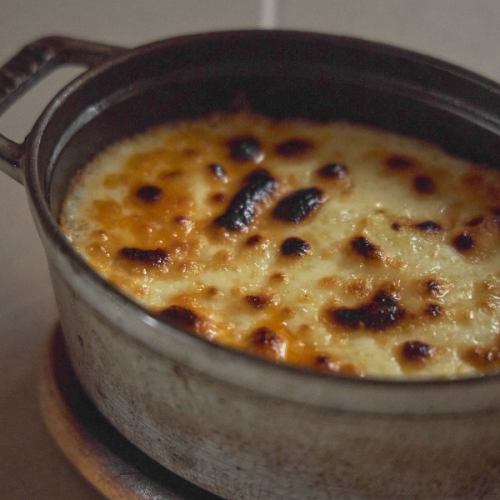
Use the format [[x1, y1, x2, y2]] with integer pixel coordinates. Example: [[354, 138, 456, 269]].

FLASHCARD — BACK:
[[60, 111, 500, 378]]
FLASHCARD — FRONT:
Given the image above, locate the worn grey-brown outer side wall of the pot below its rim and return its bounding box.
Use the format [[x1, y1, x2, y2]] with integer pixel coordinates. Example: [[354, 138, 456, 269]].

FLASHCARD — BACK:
[[50, 263, 500, 499]]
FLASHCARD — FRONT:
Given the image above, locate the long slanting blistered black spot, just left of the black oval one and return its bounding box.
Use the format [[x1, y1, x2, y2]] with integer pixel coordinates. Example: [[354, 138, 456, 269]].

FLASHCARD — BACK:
[[215, 169, 277, 231]]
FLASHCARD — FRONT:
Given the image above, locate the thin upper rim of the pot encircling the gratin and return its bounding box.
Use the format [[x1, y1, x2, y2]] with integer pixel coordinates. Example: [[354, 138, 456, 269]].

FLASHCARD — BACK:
[[22, 30, 500, 413]]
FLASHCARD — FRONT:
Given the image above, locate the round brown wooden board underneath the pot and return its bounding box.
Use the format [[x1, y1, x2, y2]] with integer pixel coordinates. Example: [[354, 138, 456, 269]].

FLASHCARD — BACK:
[[39, 329, 219, 500]]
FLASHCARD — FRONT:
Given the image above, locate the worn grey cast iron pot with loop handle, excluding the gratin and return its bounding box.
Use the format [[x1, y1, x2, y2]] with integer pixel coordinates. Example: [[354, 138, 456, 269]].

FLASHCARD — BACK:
[[0, 31, 500, 499]]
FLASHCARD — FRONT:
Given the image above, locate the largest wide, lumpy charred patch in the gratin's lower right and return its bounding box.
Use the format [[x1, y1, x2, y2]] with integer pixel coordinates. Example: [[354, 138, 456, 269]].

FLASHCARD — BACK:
[[329, 290, 406, 331]]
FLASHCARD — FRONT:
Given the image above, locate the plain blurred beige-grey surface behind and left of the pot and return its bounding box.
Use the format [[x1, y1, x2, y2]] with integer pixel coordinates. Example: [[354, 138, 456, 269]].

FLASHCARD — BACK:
[[0, 0, 500, 500]]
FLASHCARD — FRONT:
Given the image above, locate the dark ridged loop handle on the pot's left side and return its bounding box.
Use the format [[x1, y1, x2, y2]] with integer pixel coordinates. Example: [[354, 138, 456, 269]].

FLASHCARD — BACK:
[[0, 36, 126, 184]]
